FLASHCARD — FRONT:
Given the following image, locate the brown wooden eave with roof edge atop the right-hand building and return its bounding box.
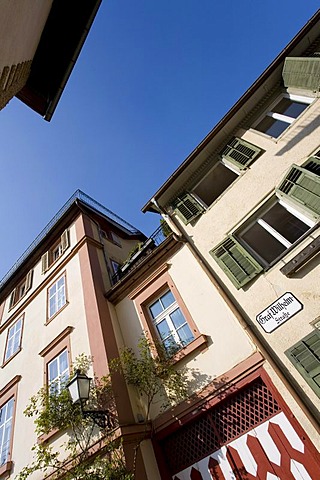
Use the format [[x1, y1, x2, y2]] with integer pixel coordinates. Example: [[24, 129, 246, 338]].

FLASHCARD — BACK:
[[141, 9, 320, 213]]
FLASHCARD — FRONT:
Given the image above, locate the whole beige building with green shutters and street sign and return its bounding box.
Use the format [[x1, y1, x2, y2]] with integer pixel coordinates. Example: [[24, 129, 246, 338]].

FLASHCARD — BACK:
[[143, 7, 320, 479]]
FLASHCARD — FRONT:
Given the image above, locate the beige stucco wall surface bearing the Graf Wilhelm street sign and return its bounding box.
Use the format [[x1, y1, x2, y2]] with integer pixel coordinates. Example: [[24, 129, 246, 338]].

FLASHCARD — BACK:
[[174, 99, 320, 442]]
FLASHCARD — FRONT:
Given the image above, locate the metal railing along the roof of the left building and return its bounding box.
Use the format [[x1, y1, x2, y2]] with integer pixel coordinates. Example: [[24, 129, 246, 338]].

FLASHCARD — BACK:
[[0, 190, 141, 289]]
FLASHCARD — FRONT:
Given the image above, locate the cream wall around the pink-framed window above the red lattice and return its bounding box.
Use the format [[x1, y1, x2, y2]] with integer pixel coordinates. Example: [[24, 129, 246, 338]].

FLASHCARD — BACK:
[[109, 246, 255, 418]]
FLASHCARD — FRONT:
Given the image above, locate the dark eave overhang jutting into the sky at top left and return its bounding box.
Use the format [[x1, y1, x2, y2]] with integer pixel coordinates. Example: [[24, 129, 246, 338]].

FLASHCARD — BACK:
[[16, 0, 102, 121]]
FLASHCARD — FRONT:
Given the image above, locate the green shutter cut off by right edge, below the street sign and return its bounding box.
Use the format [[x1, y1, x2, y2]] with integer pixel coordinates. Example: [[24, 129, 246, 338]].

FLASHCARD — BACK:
[[286, 330, 320, 397]]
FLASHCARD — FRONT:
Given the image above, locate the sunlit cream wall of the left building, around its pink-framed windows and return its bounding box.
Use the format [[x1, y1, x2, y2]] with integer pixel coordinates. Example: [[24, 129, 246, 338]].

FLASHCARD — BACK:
[[0, 221, 94, 479]]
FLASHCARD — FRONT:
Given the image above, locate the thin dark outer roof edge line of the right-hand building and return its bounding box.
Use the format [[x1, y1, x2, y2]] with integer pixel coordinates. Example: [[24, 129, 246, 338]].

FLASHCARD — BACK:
[[141, 9, 320, 213]]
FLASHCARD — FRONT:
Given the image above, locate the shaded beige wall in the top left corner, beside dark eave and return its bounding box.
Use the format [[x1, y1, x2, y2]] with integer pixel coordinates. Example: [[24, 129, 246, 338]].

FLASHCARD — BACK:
[[0, 0, 52, 72]]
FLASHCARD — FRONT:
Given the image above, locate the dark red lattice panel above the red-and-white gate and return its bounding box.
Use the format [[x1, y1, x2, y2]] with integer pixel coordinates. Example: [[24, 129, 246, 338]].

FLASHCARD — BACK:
[[162, 378, 281, 473]]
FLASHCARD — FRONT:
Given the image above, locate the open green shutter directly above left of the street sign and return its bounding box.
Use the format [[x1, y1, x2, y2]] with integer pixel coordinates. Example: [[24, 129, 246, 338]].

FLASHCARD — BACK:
[[210, 235, 263, 289]]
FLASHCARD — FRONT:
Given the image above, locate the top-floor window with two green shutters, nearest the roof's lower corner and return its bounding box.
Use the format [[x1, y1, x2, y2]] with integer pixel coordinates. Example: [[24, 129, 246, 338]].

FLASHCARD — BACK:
[[172, 137, 263, 224]]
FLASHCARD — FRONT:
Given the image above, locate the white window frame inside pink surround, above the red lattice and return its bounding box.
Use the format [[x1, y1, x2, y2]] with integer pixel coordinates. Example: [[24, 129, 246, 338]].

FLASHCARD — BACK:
[[147, 288, 195, 350]]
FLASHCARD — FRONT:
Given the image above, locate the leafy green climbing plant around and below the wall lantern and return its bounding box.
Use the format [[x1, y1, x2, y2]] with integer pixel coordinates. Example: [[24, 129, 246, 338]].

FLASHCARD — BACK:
[[16, 355, 134, 480]]
